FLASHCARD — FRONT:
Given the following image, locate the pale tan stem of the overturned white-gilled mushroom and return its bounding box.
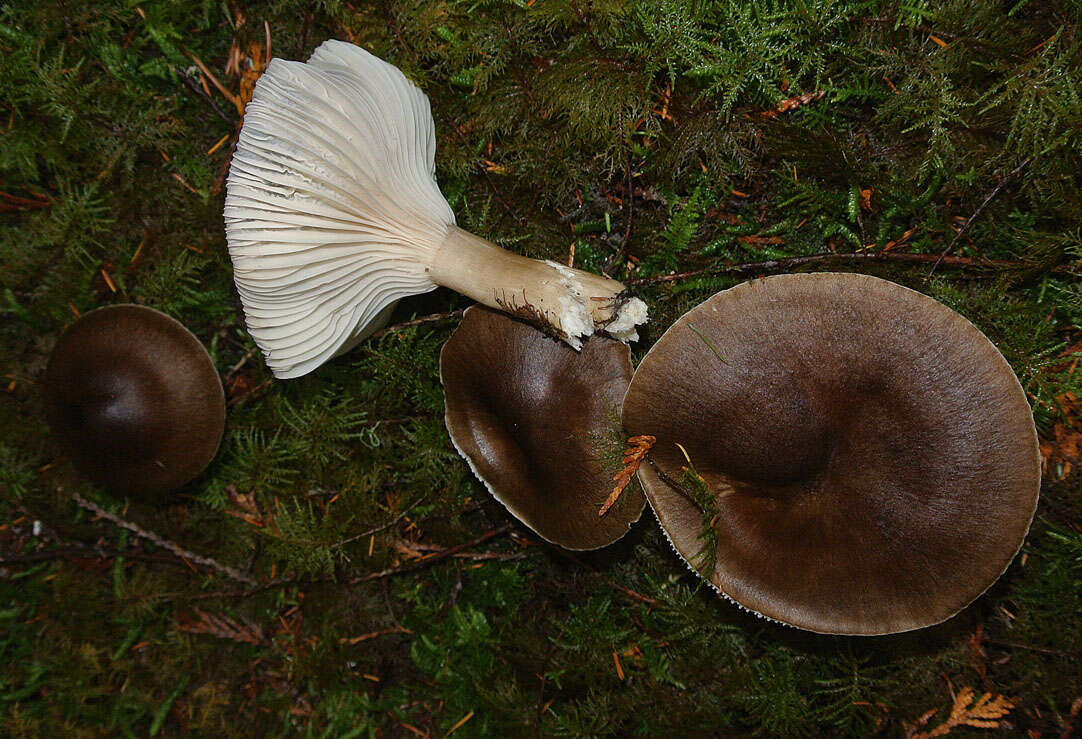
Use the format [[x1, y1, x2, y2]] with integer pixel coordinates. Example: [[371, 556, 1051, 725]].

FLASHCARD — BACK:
[[428, 225, 645, 348]]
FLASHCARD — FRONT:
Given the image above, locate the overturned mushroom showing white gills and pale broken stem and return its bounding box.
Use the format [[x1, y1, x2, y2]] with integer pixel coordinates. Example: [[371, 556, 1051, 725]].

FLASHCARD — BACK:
[[225, 40, 646, 378]]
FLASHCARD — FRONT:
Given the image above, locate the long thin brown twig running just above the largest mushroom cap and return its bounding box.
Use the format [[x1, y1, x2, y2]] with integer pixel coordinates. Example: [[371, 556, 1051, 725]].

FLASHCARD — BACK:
[[624, 251, 1056, 287]]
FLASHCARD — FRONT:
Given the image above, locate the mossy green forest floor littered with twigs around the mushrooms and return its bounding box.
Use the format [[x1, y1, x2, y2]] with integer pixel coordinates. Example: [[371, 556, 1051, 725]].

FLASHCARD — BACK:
[[0, 0, 1082, 737]]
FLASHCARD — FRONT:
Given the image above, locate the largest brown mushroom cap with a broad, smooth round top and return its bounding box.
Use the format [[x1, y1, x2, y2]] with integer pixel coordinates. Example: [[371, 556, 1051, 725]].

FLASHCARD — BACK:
[[622, 274, 1041, 634]]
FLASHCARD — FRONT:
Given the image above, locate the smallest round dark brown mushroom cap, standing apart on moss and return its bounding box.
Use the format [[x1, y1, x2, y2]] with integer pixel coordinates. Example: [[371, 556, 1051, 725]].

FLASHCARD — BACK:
[[44, 305, 225, 496]]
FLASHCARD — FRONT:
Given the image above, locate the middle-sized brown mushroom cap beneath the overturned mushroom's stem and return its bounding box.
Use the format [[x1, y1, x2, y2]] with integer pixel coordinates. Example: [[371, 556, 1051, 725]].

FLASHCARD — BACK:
[[439, 305, 646, 550]]
